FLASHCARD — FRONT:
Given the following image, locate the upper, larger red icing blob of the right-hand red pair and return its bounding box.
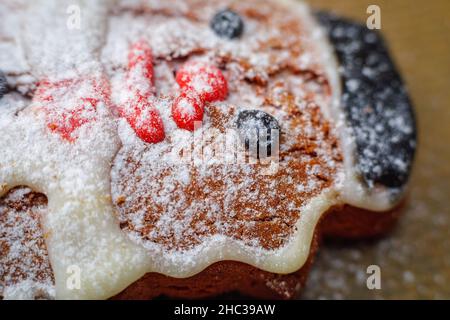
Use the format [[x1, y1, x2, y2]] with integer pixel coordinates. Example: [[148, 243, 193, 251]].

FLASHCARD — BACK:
[[176, 61, 228, 102]]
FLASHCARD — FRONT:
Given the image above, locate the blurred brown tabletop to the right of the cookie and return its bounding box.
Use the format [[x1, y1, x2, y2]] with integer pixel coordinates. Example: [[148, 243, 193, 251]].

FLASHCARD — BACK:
[[304, 0, 450, 299]]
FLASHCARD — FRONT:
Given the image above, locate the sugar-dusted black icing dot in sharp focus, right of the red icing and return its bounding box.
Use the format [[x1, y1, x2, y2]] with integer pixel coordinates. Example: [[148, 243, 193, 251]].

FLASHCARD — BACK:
[[236, 110, 280, 159]]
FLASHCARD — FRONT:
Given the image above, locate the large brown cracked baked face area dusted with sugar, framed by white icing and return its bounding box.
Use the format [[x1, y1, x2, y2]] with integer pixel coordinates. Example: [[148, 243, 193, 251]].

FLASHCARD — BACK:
[[105, 1, 343, 255]]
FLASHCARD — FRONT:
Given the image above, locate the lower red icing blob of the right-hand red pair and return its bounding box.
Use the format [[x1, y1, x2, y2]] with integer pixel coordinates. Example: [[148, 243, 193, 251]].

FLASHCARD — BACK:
[[172, 92, 203, 131]]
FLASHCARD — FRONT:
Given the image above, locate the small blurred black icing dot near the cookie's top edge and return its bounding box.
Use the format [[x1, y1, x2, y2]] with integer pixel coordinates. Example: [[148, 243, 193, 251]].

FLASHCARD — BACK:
[[210, 9, 244, 39]]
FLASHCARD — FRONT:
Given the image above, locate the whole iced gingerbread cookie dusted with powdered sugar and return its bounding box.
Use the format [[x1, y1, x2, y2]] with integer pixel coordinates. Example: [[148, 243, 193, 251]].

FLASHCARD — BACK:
[[0, 0, 416, 299]]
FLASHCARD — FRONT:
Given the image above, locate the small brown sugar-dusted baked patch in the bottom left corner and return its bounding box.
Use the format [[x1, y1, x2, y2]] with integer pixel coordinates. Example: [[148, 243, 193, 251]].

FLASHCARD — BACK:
[[0, 187, 54, 298]]
